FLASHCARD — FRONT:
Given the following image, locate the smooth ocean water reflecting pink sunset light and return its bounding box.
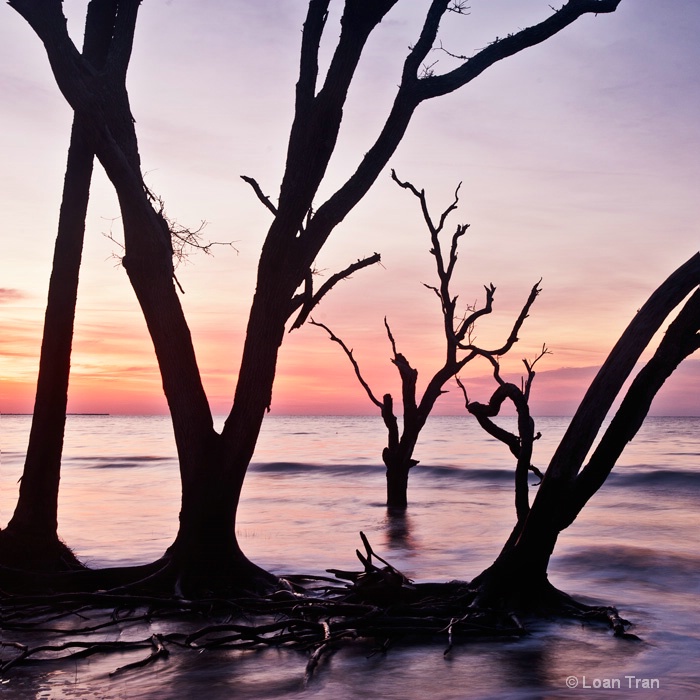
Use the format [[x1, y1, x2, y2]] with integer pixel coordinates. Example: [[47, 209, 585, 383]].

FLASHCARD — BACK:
[[0, 416, 700, 700]]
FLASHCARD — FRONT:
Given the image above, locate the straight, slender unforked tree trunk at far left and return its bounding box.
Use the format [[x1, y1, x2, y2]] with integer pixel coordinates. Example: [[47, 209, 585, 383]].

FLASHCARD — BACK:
[[0, 0, 116, 569]]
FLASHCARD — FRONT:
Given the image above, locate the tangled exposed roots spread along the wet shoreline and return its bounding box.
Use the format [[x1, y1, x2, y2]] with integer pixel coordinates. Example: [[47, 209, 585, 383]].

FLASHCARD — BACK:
[[0, 534, 636, 683]]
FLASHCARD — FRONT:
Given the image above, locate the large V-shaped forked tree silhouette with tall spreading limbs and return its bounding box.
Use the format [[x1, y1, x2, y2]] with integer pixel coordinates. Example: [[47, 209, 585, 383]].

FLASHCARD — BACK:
[[9, 0, 620, 593]]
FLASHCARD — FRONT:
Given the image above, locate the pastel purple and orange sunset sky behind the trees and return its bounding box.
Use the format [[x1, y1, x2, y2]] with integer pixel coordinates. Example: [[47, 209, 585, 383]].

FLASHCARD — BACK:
[[0, 0, 700, 415]]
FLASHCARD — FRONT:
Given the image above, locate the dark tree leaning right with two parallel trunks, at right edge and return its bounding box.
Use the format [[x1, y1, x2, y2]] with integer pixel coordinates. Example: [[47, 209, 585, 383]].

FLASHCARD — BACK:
[[472, 254, 700, 608]]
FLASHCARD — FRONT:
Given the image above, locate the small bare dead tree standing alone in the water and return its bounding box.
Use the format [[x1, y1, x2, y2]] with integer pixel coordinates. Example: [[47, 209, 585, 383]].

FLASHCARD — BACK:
[[311, 170, 540, 512]]
